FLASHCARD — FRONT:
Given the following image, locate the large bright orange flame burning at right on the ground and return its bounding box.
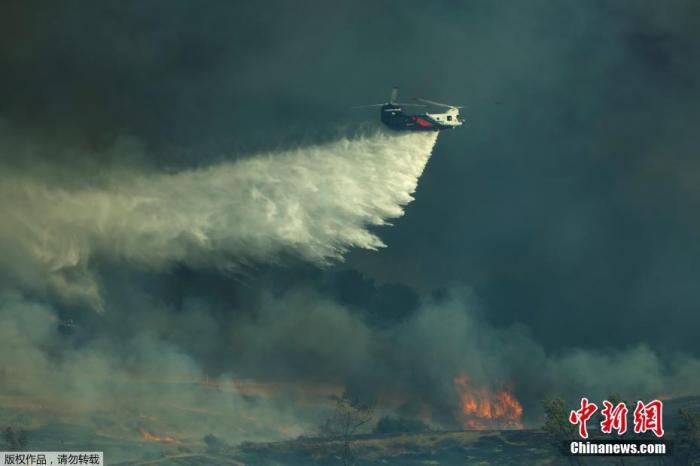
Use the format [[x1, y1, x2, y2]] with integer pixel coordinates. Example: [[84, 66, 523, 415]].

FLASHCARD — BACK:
[[454, 373, 523, 429]]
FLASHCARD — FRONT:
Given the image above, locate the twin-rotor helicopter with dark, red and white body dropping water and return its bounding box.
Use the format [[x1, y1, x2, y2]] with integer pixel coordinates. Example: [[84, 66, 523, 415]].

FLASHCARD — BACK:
[[353, 87, 464, 131]]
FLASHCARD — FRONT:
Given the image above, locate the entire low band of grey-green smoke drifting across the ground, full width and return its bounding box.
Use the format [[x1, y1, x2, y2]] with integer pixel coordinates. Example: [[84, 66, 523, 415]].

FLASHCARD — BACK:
[[0, 285, 700, 456]]
